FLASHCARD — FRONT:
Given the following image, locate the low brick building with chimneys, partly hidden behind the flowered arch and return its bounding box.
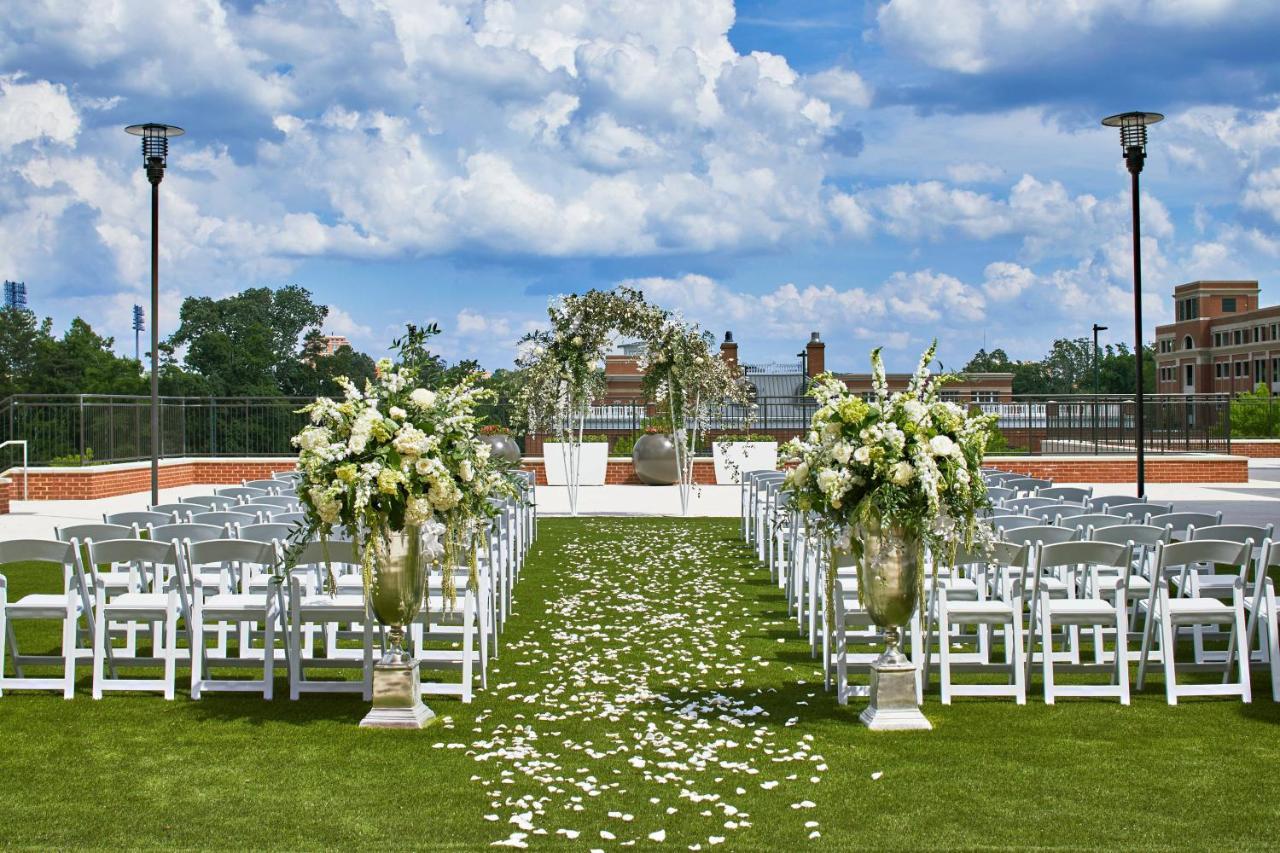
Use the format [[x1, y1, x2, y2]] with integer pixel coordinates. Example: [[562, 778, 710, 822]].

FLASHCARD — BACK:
[[604, 332, 1014, 402]]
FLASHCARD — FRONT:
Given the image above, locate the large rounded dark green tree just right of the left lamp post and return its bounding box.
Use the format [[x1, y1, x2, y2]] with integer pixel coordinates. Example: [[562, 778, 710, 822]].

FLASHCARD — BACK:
[[169, 284, 329, 396]]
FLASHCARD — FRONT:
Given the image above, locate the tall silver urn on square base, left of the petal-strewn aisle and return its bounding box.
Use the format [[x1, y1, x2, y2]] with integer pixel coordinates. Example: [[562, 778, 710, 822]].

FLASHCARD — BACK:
[[360, 525, 435, 729]]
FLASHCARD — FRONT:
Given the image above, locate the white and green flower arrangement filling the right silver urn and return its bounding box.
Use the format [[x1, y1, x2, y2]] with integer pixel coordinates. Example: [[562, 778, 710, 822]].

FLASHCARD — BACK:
[[782, 343, 995, 551]]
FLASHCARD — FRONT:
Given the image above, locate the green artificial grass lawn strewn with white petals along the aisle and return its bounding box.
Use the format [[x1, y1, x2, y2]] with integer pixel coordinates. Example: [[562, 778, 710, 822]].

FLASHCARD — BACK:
[[0, 519, 1280, 850]]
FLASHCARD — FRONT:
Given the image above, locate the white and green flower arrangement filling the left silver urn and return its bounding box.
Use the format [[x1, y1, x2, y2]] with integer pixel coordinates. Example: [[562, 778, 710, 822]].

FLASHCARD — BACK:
[[293, 350, 516, 596]]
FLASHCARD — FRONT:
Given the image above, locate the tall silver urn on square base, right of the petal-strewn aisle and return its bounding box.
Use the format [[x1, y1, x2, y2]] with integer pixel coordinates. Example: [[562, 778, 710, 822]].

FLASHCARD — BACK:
[[851, 507, 933, 731]]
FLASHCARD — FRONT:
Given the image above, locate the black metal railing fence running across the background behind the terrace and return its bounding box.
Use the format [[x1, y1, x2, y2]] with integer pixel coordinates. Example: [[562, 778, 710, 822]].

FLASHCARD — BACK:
[[0, 394, 1249, 466]]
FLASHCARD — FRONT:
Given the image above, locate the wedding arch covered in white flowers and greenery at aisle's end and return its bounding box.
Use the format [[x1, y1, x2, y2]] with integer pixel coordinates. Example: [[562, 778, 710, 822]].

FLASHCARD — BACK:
[[515, 286, 748, 515]]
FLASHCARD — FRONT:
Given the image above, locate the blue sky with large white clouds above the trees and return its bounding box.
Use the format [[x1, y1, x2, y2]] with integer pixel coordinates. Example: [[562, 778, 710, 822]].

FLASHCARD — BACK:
[[0, 0, 1280, 370]]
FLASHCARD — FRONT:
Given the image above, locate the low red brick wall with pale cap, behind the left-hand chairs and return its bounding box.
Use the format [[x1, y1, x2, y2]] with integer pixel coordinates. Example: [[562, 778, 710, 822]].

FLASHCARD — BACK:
[[6, 457, 294, 501]]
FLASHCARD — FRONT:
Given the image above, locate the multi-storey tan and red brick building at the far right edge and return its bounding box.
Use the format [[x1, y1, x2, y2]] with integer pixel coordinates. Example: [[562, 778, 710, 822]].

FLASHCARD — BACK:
[[1156, 282, 1280, 394]]
